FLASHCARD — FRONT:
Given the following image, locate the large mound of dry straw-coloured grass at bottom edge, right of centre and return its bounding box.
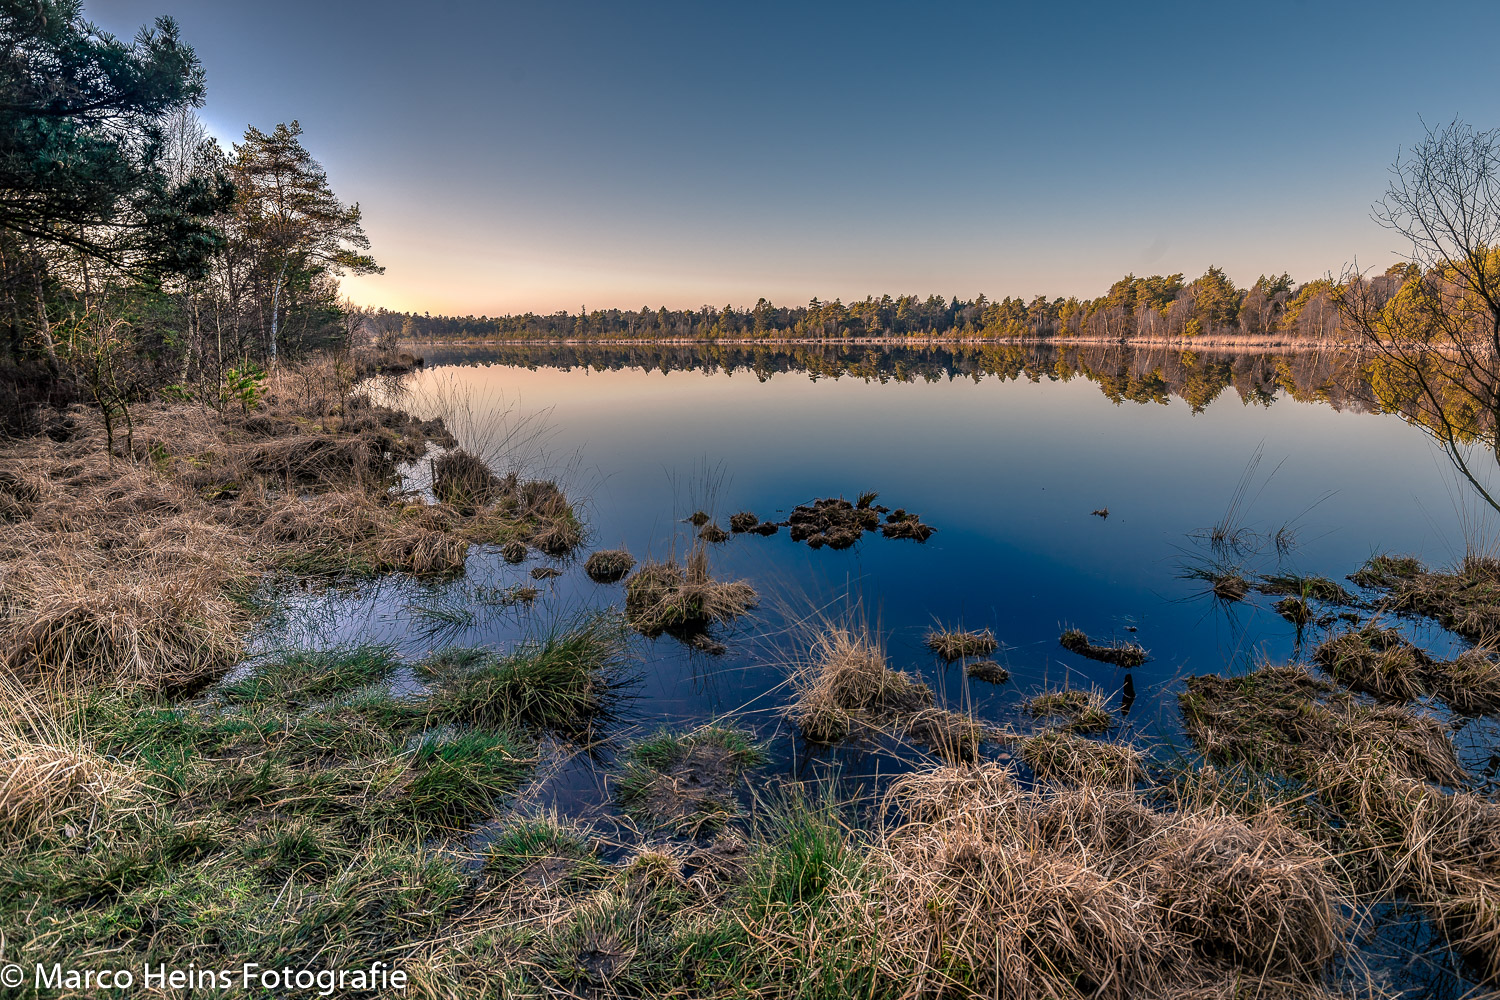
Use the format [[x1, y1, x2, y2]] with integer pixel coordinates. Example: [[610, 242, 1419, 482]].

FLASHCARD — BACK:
[[873, 765, 1344, 1000]]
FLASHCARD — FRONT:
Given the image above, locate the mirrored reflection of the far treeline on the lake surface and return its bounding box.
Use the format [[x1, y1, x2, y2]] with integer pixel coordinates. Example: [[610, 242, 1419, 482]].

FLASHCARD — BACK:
[[428, 343, 1380, 412]]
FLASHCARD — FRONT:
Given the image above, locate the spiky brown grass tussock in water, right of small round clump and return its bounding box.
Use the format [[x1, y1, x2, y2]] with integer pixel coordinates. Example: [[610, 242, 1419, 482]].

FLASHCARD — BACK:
[[626, 547, 759, 636]]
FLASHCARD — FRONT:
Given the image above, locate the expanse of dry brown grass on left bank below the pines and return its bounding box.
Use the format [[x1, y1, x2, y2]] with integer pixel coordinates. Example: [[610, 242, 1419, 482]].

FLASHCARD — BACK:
[[0, 364, 582, 690]]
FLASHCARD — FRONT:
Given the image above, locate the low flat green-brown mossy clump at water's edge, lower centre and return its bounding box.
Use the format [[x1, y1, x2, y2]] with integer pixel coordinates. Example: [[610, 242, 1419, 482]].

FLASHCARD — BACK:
[[615, 726, 764, 837]]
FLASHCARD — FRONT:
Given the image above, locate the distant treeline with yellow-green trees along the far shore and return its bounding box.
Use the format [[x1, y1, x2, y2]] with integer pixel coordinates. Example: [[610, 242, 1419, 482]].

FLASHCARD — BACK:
[[381, 264, 1410, 342]]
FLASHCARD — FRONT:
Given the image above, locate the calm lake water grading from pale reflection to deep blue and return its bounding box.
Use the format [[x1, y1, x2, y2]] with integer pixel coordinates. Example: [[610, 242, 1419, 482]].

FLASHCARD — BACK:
[[246, 352, 1500, 996]]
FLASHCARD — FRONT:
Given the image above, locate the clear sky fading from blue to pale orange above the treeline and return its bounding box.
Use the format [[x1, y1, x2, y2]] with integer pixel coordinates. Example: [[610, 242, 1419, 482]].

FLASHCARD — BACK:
[[93, 0, 1500, 315]]
